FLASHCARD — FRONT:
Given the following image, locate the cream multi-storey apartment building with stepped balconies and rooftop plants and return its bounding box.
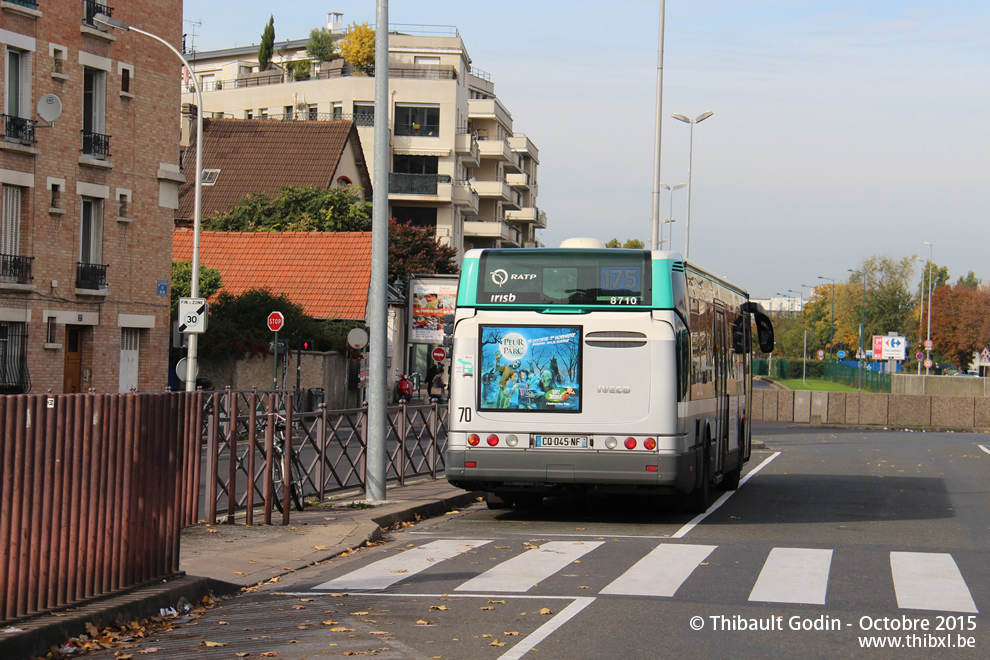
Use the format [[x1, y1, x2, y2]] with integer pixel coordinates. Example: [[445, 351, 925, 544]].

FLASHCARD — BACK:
[[183, 14, 547, 254]]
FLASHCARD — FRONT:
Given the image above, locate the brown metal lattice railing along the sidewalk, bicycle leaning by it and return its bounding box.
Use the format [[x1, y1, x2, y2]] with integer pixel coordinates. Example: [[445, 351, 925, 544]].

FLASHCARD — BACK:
[[199, 390, 447, 525]]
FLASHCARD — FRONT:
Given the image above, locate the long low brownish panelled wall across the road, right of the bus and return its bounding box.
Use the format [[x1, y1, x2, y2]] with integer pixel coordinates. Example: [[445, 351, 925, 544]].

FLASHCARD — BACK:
[[752, 390, 990, 429]]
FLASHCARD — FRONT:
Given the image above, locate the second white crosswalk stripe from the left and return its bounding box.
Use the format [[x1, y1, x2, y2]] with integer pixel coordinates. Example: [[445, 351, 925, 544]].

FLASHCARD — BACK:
[[454, 541, 602, 592]]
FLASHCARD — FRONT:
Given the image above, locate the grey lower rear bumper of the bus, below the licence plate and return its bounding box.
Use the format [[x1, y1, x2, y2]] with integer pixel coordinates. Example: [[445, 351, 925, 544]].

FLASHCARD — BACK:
[[444, 448, 700, 495]]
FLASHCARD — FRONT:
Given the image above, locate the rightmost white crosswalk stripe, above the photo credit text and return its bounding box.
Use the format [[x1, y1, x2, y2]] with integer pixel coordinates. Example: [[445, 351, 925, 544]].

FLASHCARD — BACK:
[[890, 552, 979, 614]]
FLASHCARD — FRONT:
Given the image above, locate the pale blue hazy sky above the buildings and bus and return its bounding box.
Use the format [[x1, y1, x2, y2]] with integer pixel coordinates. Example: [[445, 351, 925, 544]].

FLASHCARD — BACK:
[[184, 0, 990, 298]]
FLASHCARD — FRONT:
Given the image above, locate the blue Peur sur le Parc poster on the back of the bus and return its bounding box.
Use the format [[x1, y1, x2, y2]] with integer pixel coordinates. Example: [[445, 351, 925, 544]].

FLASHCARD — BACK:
[[479, 325, 581, 413]]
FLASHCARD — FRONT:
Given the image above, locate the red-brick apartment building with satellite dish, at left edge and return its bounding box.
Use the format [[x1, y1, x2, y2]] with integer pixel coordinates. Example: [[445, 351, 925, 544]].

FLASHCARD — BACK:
[[0, 0, 184, 394]]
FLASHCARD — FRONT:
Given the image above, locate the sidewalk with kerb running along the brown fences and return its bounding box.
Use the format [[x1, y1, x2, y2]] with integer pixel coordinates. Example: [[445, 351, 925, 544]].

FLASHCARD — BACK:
[[0, 478, 481, 659]]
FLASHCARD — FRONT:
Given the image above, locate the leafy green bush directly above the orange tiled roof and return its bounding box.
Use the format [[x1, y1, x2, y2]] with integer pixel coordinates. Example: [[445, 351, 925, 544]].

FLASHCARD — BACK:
[[203, 186, 371, 231]]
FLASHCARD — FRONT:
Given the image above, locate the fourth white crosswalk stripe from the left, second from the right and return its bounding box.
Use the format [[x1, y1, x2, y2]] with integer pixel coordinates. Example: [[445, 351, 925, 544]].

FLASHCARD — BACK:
[[749, 548, 832, 605]]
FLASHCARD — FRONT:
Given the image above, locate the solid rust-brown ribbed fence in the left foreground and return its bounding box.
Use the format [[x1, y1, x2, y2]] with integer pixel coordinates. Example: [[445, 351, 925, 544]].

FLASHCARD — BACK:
[[0, 393, 201, 621]]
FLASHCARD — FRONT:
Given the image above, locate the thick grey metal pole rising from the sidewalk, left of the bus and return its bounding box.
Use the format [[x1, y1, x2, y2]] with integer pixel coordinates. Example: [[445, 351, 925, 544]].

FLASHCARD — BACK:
[[365, 0, 390, 502]]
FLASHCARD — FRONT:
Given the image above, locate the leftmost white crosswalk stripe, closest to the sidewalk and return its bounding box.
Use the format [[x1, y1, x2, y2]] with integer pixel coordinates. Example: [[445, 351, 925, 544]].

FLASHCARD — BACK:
[[313, 540, 491, 591]]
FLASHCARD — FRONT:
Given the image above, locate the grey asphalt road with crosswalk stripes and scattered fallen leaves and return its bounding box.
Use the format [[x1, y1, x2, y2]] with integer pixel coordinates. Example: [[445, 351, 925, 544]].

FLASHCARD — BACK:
[[89, 426, 990, 658]]
